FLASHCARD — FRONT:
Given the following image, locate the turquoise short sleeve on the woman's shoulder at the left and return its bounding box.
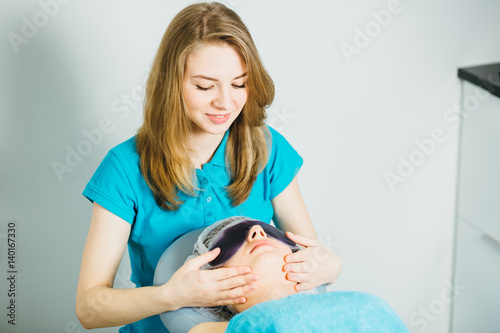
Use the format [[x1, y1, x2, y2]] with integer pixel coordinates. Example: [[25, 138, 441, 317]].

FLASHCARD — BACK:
[[82, 150, 137, 224]]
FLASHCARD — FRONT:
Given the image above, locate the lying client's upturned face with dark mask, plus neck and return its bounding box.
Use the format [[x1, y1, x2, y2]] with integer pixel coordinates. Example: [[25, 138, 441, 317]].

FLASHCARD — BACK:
[[212, 221, 298, 312]]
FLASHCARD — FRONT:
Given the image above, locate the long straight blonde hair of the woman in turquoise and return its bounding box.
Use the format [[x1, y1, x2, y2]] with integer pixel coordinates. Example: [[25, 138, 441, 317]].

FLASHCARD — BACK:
[[136, 2, 274, 210]]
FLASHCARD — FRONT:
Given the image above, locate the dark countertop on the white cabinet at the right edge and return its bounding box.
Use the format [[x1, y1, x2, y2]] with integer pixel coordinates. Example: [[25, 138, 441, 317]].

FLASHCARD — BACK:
[[458, 63, 500, 97]]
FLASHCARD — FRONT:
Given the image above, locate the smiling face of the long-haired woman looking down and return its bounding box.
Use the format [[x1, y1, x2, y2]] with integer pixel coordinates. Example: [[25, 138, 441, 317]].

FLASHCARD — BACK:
[[183, 44, 248, 135]]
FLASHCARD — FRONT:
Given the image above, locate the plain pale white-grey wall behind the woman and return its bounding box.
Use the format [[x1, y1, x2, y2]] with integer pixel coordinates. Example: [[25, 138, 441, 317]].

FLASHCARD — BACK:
[[0, 0, 500, 332]]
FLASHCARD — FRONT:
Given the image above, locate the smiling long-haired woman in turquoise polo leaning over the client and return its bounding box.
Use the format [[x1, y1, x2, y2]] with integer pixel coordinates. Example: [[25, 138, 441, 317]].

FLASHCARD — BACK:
[[76, 2, 341, 332]]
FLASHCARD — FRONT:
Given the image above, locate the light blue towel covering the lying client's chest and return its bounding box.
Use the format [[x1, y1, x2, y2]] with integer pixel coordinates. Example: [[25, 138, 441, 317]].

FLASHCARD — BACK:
[[226, 291, 409, 333]]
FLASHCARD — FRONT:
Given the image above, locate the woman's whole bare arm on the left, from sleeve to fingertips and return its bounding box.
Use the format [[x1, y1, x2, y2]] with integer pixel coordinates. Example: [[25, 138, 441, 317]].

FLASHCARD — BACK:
[[76, 203, 255, 329]]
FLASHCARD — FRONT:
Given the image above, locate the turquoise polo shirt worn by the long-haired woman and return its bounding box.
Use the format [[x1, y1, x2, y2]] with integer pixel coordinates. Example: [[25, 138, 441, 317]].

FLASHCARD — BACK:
[[83, 125, 303, 332]]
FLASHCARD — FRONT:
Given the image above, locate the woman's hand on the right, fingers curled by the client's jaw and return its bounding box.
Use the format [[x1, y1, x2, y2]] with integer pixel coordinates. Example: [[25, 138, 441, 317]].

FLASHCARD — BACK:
[[283, 231, 342, 291]]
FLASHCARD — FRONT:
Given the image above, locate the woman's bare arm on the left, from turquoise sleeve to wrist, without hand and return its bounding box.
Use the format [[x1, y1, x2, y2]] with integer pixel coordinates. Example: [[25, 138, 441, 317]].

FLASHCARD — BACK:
[[76, 203, 176, 329]]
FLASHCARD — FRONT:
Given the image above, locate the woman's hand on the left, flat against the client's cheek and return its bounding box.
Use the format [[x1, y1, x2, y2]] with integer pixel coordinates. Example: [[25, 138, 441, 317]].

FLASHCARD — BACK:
[[161, 248, 258, 310]]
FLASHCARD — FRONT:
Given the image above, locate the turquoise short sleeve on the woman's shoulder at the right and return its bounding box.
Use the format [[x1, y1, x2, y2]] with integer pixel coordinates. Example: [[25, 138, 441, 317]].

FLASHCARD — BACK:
[[267, 126, 304, 199]]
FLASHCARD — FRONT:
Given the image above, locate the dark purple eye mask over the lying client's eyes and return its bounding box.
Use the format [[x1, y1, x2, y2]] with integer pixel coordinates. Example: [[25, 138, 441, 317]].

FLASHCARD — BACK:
[[208, 220, 300, 268]]
